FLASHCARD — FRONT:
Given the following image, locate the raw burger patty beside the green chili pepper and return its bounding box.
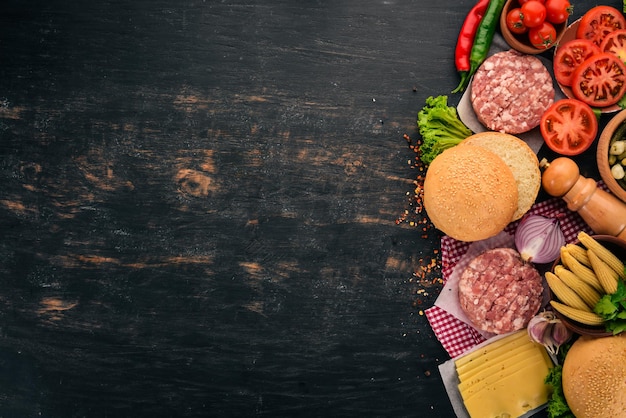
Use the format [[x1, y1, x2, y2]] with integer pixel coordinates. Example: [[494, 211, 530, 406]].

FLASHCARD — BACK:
[[470, 50, 554, 134]]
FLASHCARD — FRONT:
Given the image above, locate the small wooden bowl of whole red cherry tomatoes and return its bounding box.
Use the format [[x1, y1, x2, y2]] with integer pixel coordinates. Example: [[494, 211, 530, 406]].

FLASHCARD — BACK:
[[500, 0, 572, 54]]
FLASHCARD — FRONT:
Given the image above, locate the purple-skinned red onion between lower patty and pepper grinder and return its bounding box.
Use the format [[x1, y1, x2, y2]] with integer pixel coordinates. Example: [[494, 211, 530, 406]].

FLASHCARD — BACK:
[[515, 215, 565, 264]]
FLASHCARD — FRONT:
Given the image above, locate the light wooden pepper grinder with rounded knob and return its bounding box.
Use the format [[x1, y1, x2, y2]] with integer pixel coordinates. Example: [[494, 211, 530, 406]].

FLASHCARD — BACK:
[[539, 157, 626, 240]]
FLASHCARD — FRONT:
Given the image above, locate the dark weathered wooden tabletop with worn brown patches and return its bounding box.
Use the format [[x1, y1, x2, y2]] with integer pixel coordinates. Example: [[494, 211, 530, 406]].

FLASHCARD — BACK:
[[0, 0, 617, 418]]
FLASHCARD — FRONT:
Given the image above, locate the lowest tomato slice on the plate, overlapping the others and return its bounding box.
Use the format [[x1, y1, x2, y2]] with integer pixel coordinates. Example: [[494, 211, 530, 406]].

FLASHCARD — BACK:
[[572, 52, 626, 107]]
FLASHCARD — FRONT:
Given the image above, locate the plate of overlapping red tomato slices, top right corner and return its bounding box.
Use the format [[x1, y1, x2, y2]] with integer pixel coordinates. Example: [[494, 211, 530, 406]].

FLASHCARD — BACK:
[[553, 5, 626, 113]]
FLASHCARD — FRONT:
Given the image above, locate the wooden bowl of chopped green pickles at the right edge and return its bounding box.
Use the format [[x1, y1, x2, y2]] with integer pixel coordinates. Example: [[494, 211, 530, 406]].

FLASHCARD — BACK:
[[596, 110, 626, 202]]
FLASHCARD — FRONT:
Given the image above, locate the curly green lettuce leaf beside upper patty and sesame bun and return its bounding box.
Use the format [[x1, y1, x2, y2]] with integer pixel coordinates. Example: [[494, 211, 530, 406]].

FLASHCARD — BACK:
[[417, 96, 473, 164]]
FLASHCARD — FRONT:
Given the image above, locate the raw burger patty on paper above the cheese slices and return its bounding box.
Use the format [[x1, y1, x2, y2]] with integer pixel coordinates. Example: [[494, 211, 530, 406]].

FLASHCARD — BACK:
[[459, 248, 543, 334]]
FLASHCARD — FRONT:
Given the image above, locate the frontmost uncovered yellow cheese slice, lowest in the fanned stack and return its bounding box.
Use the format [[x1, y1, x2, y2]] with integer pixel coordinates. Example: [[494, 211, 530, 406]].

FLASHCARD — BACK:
[[463, 358, 551, 418]]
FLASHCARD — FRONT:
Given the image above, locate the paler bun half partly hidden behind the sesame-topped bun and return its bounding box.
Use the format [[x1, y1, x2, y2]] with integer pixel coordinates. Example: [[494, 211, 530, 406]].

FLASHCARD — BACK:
[[461, 131, 541, 221]]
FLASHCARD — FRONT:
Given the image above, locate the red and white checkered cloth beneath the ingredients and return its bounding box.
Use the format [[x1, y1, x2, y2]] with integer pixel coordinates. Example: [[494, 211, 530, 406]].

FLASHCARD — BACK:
[[424, 193, 606, 358]]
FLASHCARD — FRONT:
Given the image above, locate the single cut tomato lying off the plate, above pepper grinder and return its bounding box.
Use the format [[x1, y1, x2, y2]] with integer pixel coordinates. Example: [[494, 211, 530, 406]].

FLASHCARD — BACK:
[[539, 99, 598, 156]]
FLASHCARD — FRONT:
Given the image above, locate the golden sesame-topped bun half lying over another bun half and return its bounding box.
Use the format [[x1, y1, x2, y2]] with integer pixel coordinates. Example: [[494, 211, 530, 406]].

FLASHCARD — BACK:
[[424, 146, 518, 241]]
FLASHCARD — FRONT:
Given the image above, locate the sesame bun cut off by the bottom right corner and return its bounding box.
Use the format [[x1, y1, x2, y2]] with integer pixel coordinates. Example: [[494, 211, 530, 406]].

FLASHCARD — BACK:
[[563, 333, 626, 418]]
